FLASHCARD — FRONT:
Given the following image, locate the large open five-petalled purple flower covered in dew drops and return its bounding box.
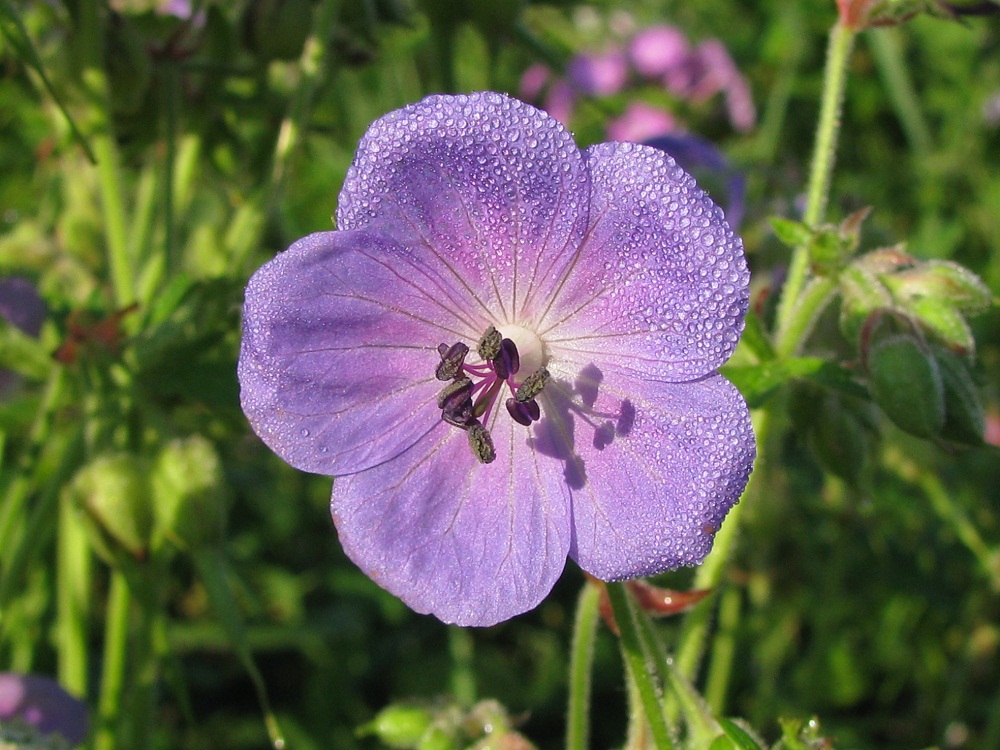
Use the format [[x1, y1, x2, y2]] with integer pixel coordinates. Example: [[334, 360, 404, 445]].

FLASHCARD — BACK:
[[239, 93, 755, 625]]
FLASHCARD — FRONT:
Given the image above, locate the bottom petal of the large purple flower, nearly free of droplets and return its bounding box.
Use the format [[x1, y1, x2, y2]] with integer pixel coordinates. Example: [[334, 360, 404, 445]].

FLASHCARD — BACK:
[[331, 414, 570, 626]]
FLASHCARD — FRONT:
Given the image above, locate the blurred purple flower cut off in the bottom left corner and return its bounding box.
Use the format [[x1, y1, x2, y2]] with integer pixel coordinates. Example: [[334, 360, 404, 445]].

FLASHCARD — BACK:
[[0, 672, 87, 745]]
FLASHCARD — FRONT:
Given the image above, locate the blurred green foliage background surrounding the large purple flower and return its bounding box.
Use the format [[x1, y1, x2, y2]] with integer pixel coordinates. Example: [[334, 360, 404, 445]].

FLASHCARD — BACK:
[[0, 0, 1000, 750]]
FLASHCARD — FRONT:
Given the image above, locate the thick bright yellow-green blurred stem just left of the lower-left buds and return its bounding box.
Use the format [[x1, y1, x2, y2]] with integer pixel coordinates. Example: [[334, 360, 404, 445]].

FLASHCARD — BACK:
[[56, 493, 91, 697]]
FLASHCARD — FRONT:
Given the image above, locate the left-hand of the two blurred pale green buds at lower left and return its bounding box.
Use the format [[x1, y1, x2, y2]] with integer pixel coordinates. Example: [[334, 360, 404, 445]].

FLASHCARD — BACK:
[[70, 453, 153, 557]]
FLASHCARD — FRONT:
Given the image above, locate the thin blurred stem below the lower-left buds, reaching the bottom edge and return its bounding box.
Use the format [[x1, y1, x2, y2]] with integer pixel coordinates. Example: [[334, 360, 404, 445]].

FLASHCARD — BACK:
[[94, 570, 132, 750]]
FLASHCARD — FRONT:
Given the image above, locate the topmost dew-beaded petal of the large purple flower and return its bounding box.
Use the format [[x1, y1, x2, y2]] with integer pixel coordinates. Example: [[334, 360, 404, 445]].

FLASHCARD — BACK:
[[337, 92, 589, 325]]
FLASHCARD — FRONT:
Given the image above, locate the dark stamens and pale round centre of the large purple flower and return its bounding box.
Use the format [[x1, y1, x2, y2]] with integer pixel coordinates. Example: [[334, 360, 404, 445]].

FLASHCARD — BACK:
[[434, 326, 549, 464]]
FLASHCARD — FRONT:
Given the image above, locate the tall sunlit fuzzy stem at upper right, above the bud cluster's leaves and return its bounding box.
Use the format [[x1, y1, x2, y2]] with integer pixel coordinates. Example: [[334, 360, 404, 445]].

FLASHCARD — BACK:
[[777, 22, 857, 356]]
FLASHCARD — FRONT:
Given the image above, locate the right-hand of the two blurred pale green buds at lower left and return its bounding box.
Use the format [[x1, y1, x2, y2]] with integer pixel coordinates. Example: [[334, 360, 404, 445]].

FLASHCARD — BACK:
[[152, 435, 226, 549]]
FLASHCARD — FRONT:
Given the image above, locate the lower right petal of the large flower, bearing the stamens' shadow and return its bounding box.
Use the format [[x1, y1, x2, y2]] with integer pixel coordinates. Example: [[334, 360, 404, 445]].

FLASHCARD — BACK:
[[535, 365, 756, 580]]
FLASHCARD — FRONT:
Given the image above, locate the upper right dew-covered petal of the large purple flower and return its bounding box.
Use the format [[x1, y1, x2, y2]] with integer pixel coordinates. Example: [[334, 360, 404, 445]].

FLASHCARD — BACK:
[[538, 143, 750, 382]]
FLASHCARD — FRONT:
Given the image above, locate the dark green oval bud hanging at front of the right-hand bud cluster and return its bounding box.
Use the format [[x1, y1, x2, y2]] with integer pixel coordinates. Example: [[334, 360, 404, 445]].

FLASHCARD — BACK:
[[868, 334, 945, 438]]
